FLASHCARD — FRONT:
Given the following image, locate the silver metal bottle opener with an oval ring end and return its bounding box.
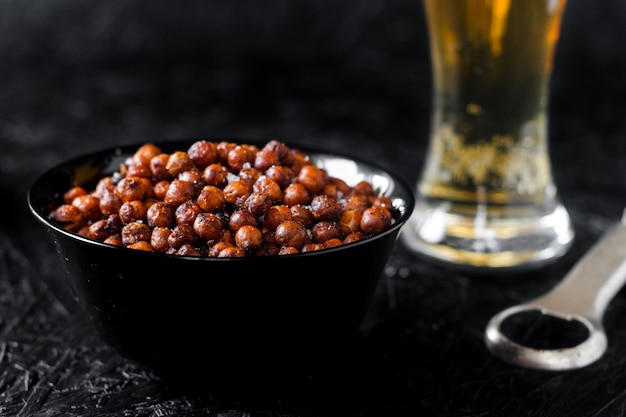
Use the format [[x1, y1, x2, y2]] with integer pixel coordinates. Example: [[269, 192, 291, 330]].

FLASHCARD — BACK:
[[485, 210, 626, 370]]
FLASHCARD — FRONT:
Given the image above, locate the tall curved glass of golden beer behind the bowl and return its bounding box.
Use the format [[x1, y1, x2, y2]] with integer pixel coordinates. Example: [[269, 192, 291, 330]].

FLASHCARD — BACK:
[[401, 0, 574, 268]]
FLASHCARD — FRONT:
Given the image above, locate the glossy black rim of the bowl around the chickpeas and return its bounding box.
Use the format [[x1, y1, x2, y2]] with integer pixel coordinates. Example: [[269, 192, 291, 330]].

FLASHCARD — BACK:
[[26, 137, 415, 262]]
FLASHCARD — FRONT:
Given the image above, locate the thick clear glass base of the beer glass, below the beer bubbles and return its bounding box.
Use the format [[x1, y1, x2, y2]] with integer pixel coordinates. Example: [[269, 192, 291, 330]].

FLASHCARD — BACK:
[[400, 197, 574, 270]]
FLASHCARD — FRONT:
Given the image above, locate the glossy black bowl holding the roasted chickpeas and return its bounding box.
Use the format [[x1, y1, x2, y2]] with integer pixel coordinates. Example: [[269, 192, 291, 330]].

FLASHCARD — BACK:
[[28, 141, 414, 381]]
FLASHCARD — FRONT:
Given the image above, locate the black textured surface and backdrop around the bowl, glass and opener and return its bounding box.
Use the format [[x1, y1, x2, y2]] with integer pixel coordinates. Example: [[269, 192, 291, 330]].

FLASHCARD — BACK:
[[0, 0, 626, 417]]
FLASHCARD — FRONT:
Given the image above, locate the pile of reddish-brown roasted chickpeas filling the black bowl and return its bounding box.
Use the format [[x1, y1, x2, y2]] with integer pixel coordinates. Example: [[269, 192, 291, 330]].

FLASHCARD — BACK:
[[50, 140, 395, 257]]
